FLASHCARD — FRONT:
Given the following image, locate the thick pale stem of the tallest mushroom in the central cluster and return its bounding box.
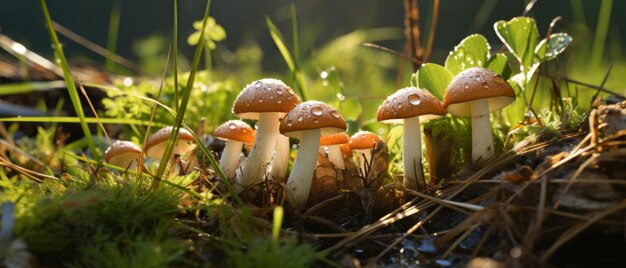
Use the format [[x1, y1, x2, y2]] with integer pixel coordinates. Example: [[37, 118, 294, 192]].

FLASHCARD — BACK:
[[238, 113, 279, 186]]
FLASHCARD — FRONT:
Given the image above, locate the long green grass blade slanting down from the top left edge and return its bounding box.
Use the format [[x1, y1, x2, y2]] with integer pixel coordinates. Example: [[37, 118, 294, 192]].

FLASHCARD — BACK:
[[40, 0, 100, 159]]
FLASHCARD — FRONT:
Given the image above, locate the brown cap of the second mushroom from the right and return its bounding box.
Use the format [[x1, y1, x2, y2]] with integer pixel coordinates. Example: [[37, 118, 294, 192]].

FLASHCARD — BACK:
[[376, 87, 446, 123]]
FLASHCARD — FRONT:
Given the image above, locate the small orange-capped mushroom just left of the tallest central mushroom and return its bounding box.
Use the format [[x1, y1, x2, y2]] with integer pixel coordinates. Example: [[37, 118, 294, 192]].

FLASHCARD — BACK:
[[213, 120, 255, 178]]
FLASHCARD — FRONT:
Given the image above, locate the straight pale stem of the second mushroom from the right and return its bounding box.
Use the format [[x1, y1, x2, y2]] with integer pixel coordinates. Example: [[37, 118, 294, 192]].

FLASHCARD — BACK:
[[402, 116, 426, 191]]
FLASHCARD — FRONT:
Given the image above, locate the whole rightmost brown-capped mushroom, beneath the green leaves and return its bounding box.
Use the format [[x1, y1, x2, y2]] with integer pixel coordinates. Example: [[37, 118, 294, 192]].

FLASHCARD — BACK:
[[443, 67, 515, 163]]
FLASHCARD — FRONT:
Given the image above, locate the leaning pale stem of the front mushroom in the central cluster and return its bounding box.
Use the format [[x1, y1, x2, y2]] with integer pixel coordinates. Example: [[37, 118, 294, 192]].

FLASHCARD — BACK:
[[287, 129, 320, 210]]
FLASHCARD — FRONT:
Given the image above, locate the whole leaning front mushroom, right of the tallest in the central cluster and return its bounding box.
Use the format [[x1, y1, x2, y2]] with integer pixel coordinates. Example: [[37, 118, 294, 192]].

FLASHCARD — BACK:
[[280, 101, 347, 210]]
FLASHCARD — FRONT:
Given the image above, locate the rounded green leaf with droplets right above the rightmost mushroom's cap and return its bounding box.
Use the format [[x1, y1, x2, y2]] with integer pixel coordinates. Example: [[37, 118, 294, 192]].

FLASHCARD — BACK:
[[445, 34, 489, 75]]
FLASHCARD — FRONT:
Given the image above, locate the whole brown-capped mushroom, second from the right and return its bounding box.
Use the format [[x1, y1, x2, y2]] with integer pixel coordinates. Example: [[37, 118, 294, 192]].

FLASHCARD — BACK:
[[376, 87, 446, 190]]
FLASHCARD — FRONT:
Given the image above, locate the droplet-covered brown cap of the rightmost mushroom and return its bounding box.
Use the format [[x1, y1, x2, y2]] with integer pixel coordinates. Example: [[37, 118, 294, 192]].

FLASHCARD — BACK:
[[443, 67, 515, 116]]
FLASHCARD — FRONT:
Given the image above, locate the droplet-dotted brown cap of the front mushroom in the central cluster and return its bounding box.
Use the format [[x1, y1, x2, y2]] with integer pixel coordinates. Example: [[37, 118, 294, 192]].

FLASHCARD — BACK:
[[280, 101, 347, 139]]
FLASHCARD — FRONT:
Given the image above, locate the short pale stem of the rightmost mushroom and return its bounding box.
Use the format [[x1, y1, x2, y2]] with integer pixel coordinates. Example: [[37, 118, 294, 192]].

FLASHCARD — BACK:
[[470, 99, 493, 163]]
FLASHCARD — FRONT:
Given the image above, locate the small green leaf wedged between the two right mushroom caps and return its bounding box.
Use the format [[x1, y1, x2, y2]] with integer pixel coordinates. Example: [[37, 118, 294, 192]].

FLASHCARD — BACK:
[[415, 63, 454, 100]]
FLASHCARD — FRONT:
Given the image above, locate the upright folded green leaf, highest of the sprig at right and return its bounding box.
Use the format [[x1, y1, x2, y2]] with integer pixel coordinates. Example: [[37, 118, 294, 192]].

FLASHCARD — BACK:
[[494, 17, 539, 73]]
